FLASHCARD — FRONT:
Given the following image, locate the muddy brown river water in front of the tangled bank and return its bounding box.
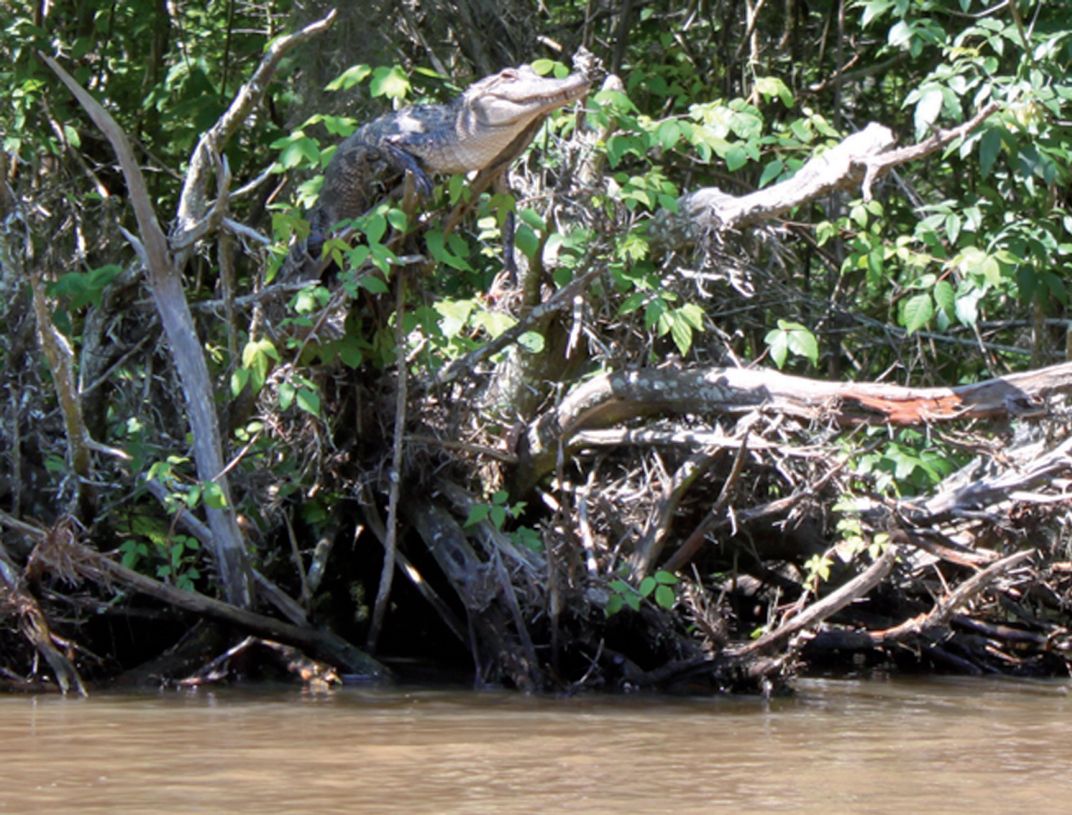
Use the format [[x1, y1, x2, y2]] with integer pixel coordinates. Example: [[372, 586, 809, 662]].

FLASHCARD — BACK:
[[0, 680, 1072, 815]]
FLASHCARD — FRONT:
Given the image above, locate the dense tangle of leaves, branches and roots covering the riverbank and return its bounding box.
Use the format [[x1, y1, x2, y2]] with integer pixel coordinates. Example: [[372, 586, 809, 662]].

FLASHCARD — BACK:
[[0, 0, 1072, 690]]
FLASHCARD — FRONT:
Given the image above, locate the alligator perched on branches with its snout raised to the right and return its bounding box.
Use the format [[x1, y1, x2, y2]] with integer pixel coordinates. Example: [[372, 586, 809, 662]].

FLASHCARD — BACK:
[[292, 65, 590, 276]]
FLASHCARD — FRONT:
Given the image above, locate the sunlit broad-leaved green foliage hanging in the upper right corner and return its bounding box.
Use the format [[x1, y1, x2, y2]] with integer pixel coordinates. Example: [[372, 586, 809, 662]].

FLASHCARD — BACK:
[[847, 0, 1072, 343]]
